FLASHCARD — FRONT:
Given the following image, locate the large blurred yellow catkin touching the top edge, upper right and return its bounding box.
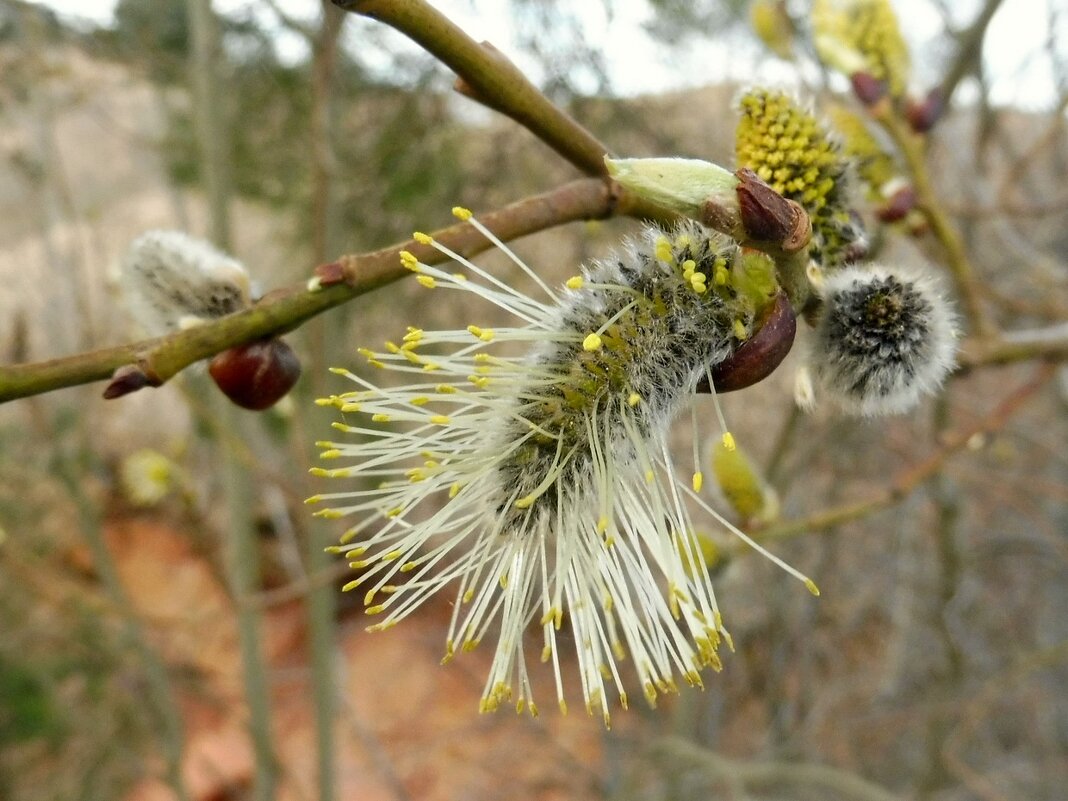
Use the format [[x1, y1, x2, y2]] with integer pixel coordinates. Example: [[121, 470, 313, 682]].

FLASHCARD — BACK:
[[811, 0, 910, 97]]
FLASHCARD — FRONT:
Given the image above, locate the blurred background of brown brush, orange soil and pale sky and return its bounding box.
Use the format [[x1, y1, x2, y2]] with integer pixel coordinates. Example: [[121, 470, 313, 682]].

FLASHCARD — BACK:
[[0, 0, 1068, 801]]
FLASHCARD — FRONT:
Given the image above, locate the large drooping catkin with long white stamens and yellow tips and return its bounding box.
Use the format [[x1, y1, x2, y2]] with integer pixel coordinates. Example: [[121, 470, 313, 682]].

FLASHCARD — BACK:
[[310, 209, 815, 723]]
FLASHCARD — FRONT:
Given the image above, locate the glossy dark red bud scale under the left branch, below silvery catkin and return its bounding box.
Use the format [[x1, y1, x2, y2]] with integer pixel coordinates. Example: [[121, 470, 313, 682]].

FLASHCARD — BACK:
[[208, 339, 300, 411]]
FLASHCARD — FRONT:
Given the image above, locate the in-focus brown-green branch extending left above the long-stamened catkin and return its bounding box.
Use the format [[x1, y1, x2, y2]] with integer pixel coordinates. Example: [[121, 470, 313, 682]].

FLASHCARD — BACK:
[[0, 178, 619, 403]]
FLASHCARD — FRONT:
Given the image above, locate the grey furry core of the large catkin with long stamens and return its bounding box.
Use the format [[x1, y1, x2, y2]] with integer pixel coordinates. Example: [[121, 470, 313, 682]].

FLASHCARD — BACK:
[[499, 223, 751, 529]]
